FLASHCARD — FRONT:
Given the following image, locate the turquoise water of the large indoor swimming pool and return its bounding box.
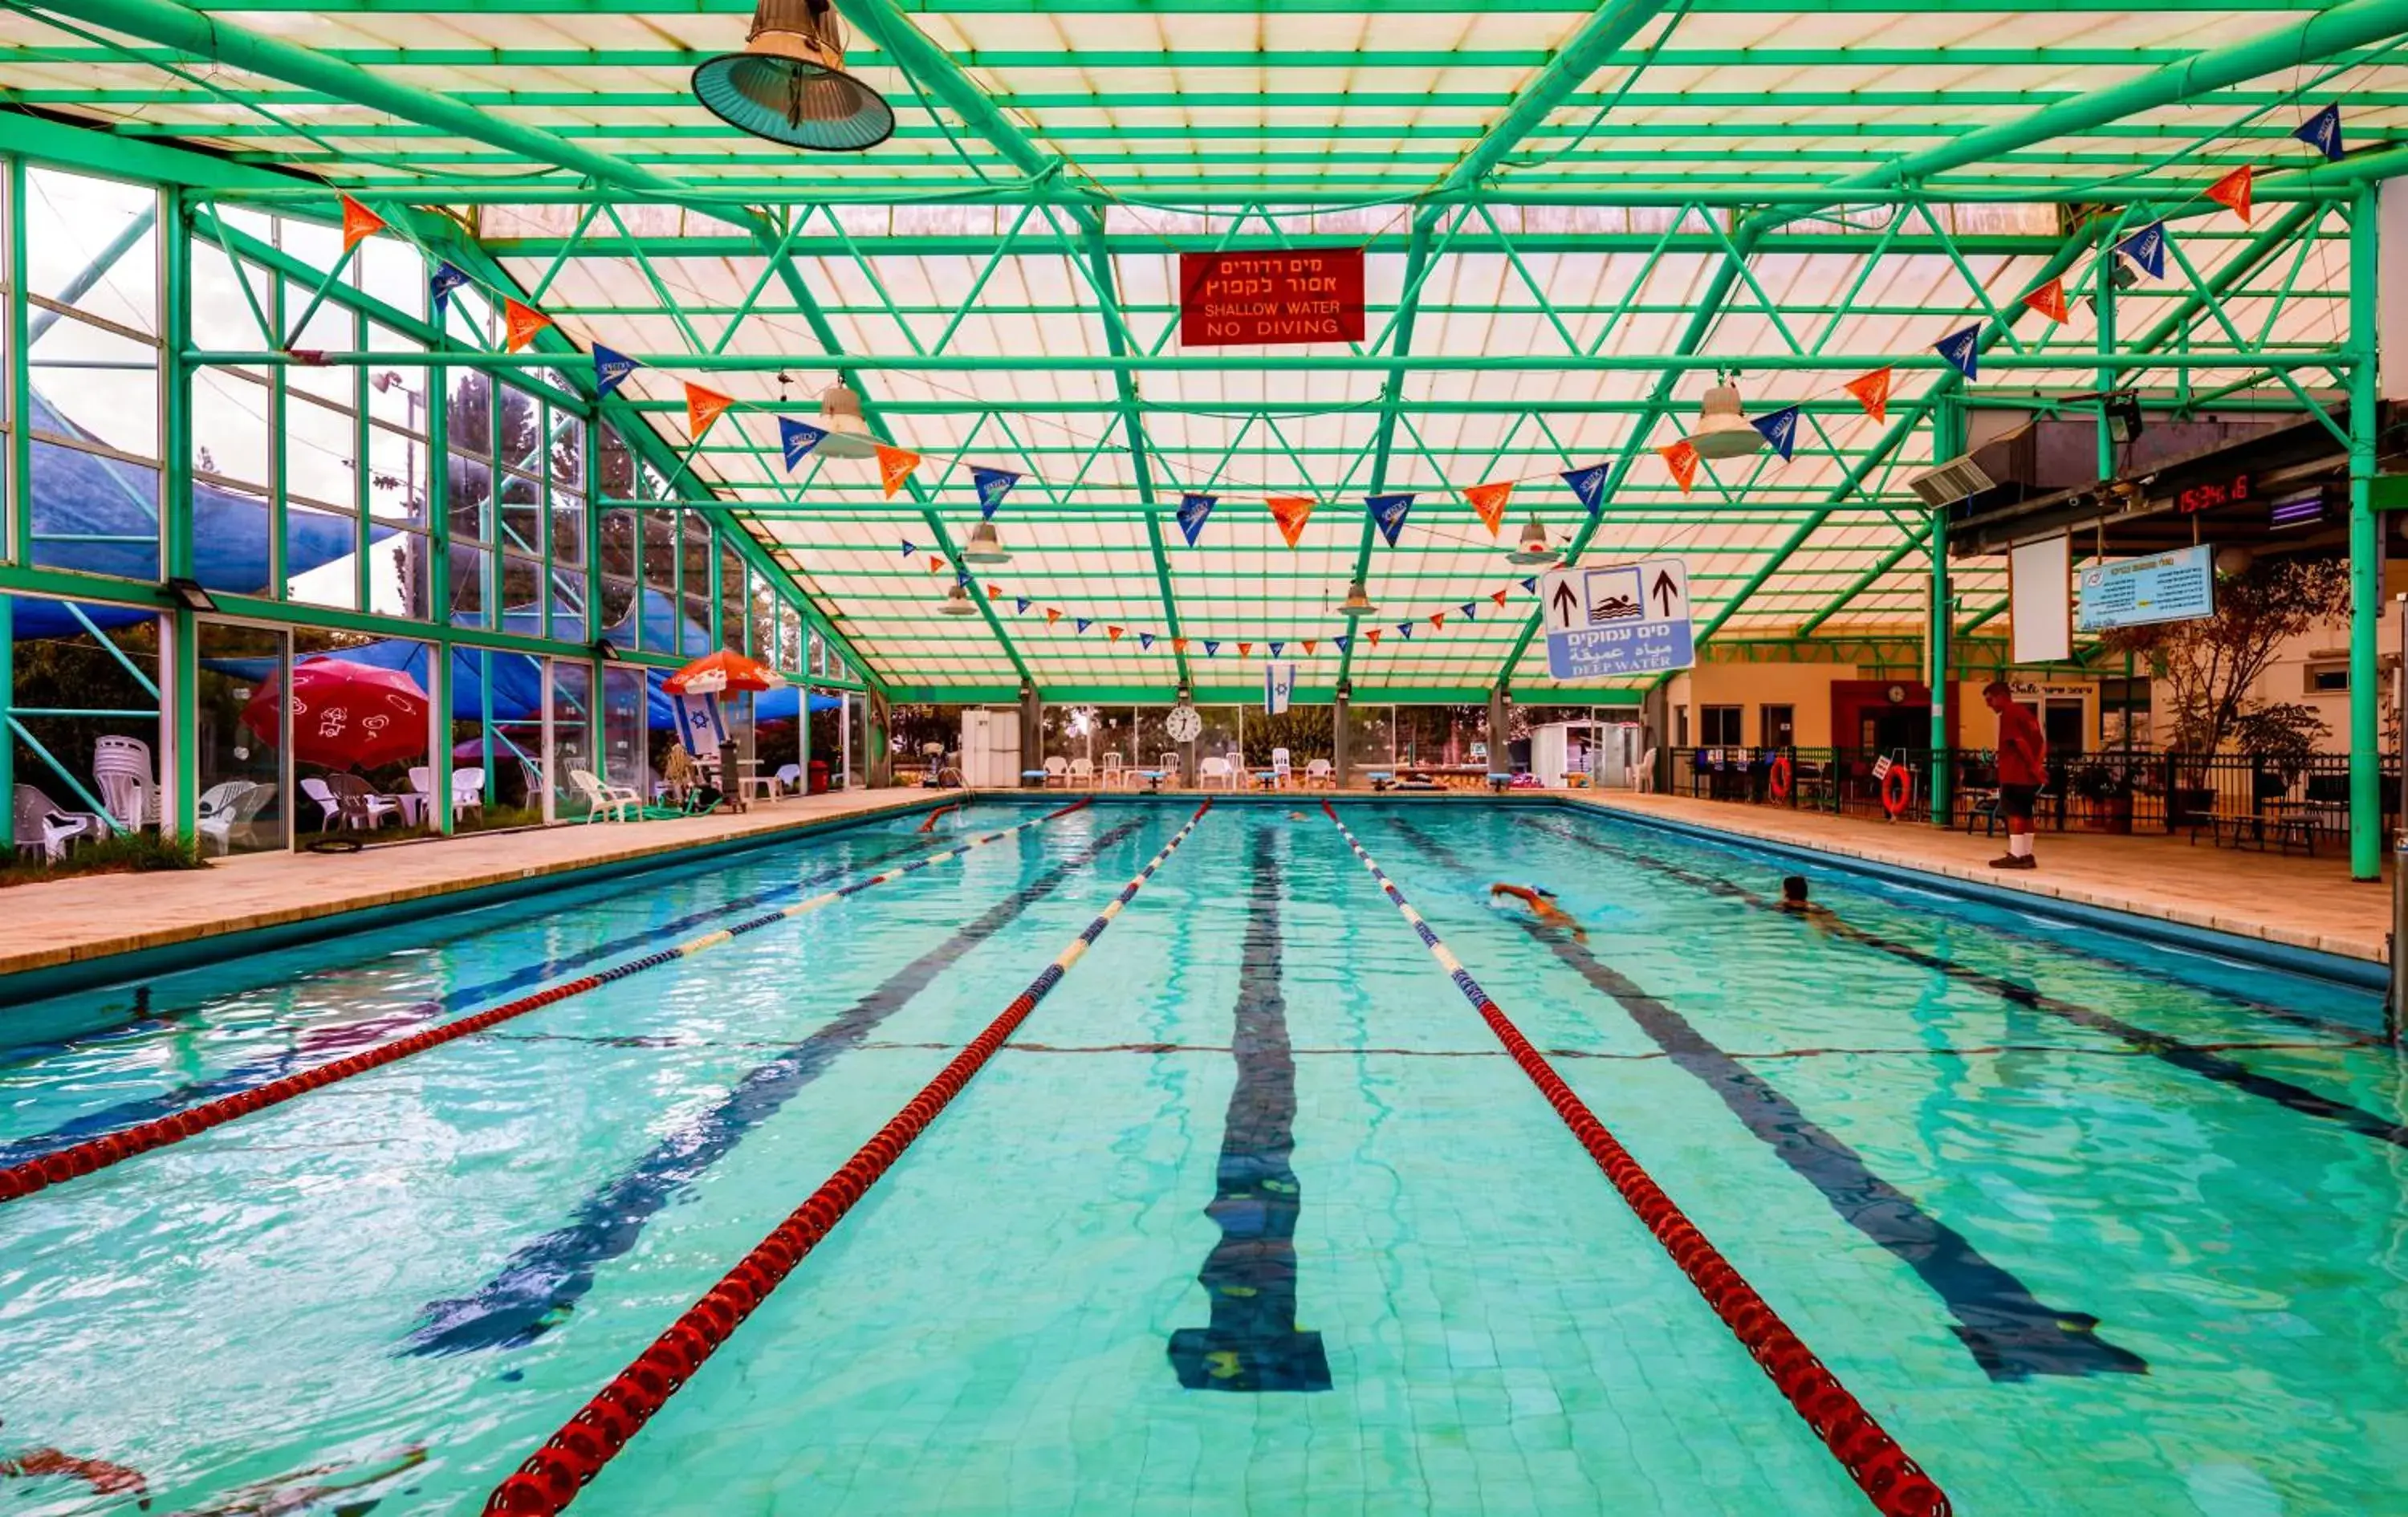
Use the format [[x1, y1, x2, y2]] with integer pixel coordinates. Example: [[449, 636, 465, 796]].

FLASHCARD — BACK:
[[0, 799, 2408, 1517]]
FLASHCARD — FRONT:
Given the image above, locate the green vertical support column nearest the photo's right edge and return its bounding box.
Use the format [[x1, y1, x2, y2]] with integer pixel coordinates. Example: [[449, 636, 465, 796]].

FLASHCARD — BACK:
[[2350, 188, 2384, 879]]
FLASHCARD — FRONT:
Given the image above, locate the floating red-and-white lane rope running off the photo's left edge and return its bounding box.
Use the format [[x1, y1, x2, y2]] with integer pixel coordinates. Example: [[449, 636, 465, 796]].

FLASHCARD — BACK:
[[0, 802, 1086, 1204]]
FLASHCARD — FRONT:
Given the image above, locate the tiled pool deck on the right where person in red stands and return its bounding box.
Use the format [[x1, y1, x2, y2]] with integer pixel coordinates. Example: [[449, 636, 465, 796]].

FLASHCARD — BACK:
[[1575, 790, 2391, 963]]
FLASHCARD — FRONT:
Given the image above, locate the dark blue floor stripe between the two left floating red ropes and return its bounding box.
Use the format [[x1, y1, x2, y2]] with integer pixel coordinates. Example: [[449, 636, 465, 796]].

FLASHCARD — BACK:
[[400, 816, 1144, 1356]]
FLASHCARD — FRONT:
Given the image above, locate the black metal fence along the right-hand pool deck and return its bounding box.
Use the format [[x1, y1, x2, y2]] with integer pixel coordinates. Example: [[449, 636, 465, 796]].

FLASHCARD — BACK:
[[1657, 749, 2401, 852]]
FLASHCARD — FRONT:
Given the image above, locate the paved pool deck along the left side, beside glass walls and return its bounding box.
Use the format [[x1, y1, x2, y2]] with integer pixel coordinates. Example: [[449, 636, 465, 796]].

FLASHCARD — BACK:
[[0, 790, 932, 978]]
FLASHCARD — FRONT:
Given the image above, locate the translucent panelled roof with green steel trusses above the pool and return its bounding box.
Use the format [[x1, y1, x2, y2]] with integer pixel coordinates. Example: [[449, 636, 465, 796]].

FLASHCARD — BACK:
[[0, 0, 2408, 701]]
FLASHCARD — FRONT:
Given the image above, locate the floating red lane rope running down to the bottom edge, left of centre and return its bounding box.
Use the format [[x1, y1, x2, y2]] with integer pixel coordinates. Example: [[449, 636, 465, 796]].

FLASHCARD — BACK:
[[484, 799, 1211, 1517]]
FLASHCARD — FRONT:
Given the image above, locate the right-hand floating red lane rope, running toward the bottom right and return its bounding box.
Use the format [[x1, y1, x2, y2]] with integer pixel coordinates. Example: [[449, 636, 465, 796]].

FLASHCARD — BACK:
[[1322, 802, 1950, 1517]]
